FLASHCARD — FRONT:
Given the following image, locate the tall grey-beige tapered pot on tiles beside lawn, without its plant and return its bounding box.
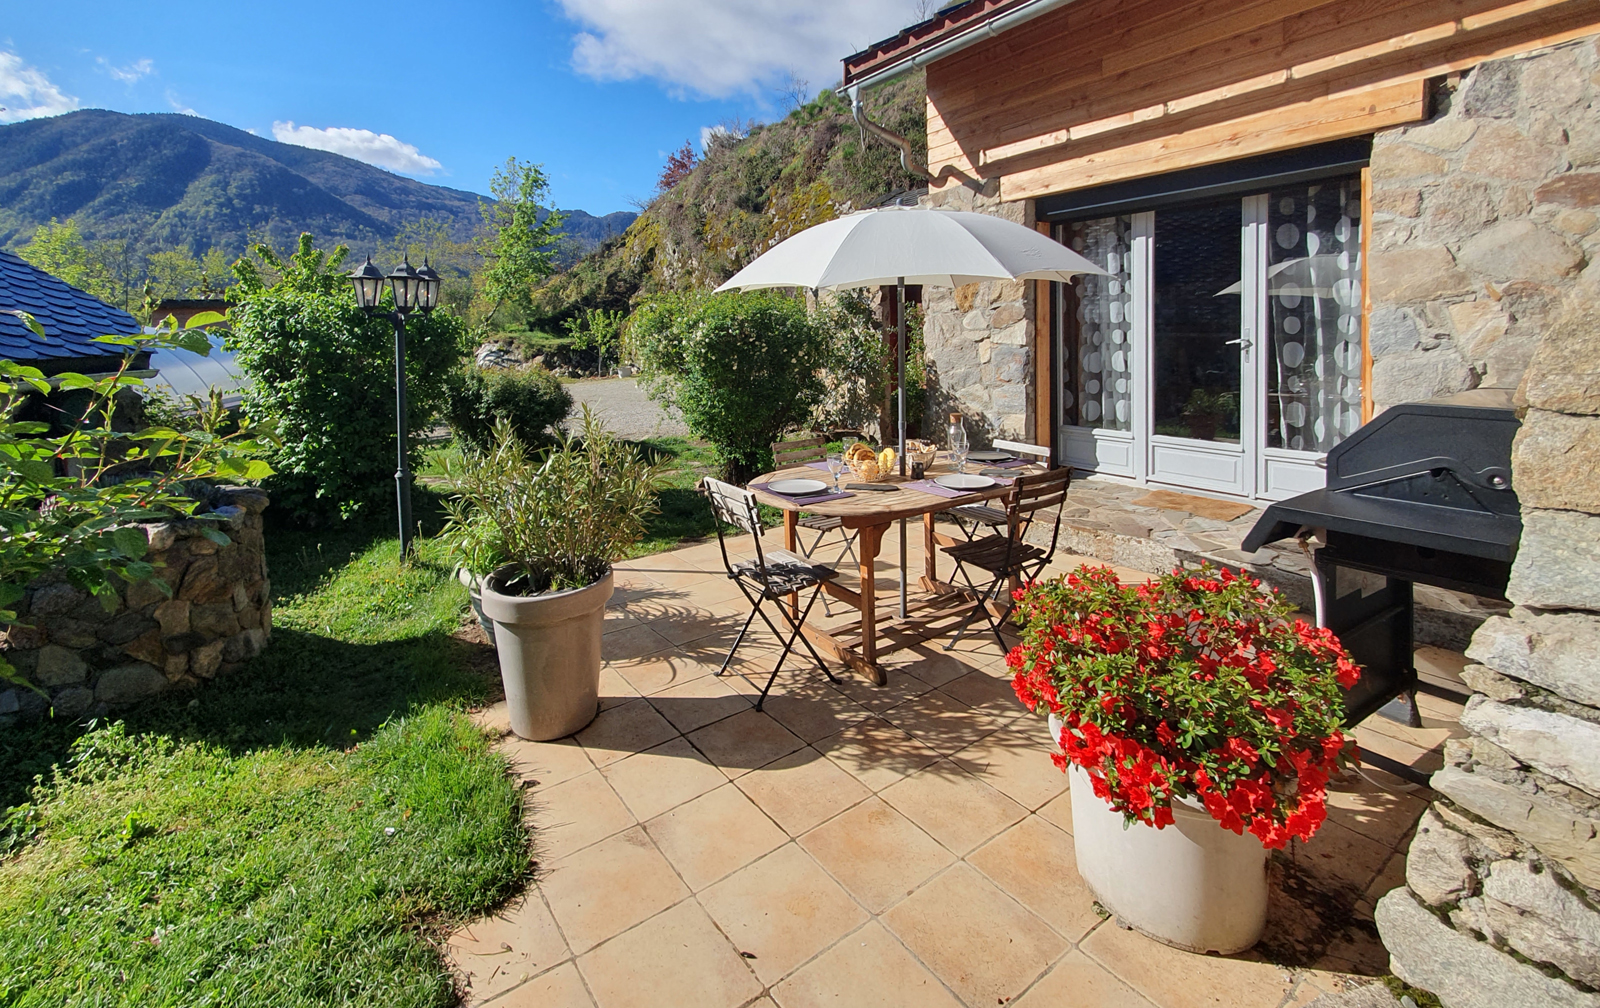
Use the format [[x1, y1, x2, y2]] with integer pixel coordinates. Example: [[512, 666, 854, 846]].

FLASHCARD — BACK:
[[482, 566, 613, 741]]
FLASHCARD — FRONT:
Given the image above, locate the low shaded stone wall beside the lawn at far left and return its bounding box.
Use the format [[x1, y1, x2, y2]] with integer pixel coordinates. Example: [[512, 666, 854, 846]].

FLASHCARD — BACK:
[[0, 486, 272, 726]]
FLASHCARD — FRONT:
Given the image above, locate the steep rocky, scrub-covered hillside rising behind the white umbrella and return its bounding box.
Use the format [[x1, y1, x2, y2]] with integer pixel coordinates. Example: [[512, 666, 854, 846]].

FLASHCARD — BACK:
[[531, 74, 928, 333]]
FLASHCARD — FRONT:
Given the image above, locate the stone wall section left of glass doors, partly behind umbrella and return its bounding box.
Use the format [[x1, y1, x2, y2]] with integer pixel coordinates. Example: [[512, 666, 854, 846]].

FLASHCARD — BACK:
[[923, 182, 1037, 445]]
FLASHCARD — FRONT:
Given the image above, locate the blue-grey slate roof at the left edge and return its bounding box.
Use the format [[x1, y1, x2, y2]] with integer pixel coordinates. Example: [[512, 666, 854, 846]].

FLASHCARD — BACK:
[[0, 251, 141, 360]]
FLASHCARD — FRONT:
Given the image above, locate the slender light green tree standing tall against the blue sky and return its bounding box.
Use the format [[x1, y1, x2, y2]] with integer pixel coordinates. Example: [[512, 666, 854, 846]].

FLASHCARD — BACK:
[[478, 157, 566, 318]]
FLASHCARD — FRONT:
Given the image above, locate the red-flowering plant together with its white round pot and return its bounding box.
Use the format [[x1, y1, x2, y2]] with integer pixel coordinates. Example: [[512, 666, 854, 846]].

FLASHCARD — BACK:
[[1006, 566, 1360, 954]]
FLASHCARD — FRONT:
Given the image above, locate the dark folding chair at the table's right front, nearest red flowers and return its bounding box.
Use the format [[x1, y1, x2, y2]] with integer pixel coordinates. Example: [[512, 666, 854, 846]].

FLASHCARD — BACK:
[[944, 469, 1072, 653]]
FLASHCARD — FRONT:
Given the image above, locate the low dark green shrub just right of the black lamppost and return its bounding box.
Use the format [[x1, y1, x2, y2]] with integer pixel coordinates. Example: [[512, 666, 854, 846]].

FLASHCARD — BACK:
[[445, 365, 573, 450]]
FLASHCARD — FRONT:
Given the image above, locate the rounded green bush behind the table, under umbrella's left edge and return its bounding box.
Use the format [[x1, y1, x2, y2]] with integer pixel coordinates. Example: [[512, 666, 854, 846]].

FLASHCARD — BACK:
[[629, 291, 827, 482]]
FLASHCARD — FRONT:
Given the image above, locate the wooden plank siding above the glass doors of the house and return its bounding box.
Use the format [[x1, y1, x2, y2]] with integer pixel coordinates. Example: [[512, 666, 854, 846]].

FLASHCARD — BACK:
[[928, 0, 1600, 200]]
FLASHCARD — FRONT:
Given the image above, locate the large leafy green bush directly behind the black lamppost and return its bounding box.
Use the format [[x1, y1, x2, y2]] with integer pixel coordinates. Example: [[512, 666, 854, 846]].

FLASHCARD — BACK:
[[227, 234, 466, 520]]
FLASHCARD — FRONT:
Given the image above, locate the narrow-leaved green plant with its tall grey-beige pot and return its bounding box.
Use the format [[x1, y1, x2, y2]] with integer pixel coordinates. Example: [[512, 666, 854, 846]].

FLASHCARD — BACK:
[[445, 406, 661, 739]]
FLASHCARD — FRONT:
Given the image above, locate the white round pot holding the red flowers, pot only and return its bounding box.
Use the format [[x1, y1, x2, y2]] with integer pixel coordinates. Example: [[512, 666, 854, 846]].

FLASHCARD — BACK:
[[1050, 717, 1267, 955]]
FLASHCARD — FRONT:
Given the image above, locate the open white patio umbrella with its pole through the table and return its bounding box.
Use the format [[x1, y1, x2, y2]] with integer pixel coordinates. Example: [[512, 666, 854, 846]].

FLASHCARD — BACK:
[[717, 206, 1107, 619]]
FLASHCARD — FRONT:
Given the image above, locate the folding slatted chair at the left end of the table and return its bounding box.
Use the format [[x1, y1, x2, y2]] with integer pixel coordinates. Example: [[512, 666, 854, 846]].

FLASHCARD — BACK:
[[701, 477, 838, 710]]
